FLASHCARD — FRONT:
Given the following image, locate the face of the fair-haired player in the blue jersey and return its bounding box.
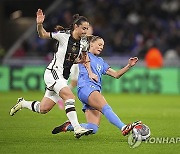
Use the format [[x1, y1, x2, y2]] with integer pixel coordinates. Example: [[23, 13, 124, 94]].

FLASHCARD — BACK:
[[90, 39, 104, 55]]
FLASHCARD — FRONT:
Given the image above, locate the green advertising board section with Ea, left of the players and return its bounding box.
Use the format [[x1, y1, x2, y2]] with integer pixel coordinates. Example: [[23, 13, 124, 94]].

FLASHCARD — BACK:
[[0, 67, 45, 91]]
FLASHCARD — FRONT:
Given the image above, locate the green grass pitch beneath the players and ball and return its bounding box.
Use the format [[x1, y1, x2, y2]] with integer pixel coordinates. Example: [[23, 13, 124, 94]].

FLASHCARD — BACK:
[[0, 91, 180, 154]]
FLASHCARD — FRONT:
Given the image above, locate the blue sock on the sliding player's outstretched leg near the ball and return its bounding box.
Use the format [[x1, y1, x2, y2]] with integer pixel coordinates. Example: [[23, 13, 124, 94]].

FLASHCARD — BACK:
[[102, 104, 125, 129]]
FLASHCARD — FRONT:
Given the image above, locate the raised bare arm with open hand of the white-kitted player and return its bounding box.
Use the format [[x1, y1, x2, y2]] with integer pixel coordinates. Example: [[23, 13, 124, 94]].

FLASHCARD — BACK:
[[36, 9, 51, 39]]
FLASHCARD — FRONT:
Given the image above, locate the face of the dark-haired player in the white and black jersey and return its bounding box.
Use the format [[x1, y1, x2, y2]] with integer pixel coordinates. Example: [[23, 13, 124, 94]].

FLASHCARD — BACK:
[[76, 22, 89, 37]]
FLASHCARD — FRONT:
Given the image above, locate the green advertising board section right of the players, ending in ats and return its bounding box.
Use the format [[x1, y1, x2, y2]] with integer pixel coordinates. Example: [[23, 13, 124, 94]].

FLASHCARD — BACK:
[[102, 68, 180, 94]]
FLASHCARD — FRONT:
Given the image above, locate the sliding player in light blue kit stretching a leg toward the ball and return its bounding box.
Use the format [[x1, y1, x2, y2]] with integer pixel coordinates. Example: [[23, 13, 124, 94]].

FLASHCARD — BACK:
[[52, 36, 141, 136]]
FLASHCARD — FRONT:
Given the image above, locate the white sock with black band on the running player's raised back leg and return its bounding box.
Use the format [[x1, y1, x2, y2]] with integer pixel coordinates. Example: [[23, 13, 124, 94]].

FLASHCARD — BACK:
[[22, 101, 40, 113]]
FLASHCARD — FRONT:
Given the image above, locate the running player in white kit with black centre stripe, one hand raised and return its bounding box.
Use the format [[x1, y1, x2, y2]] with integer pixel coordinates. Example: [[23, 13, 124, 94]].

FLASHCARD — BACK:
[[10, 9, 97, 138]]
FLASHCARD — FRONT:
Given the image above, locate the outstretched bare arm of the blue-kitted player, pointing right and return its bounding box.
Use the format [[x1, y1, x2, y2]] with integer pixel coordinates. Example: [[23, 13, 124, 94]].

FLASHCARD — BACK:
[[106, 57, 138, 79]]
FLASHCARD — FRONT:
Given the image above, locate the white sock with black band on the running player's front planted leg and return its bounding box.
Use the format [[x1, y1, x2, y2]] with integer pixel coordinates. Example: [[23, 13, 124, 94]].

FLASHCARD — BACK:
[[65, 99, 81, 131]]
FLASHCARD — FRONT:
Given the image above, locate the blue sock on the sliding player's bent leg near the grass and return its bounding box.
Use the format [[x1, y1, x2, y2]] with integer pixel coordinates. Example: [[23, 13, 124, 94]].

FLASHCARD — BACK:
[[67, 123, 99, 134]]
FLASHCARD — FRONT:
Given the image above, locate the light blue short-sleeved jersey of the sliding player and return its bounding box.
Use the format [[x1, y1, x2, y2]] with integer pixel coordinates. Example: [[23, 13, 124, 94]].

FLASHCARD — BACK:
[[77, 52, 110, 89]]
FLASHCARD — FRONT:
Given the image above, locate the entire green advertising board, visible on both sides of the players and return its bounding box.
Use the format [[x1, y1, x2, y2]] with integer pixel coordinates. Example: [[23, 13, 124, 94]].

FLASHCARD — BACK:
[[0, 66, 180, 94]]
